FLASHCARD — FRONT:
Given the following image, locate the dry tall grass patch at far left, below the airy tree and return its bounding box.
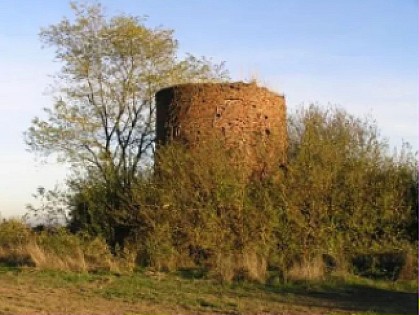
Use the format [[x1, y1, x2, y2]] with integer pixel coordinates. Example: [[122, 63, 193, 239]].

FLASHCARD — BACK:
[[0, 219, 135, 272]]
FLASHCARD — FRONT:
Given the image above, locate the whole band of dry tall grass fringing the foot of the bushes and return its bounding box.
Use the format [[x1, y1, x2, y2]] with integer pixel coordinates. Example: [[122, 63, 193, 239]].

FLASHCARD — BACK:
[[0, 219, 418, 283]]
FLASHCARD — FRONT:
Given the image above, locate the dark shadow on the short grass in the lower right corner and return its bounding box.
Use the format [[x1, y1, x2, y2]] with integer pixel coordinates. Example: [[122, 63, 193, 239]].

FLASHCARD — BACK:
[[266, 284, 419, 314]]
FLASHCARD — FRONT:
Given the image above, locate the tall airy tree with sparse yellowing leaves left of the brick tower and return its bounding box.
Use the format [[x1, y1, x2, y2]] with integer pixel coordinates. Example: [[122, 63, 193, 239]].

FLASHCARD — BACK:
[[26, 3, 227, 243]]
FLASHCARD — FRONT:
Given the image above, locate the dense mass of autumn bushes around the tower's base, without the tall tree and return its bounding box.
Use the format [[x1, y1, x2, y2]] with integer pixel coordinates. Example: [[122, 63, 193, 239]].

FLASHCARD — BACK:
[[24, 106, 418, 281]]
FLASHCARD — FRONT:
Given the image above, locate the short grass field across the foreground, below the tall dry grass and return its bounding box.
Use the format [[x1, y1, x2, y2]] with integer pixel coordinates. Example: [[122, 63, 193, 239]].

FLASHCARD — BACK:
[[0, 267, 418, 315]]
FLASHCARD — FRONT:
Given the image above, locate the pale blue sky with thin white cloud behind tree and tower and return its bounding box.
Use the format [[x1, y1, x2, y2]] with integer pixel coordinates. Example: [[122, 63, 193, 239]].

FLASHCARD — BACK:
[[0, 0, 418, 216]]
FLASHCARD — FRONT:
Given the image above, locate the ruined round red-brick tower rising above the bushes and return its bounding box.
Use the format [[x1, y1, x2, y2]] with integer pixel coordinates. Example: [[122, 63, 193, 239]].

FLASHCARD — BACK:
[[156, 82, 287, 178]]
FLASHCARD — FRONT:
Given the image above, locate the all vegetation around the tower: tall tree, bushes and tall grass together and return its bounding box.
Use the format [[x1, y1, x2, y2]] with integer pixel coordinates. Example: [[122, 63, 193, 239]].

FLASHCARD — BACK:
[[13, 1, 418, 283]]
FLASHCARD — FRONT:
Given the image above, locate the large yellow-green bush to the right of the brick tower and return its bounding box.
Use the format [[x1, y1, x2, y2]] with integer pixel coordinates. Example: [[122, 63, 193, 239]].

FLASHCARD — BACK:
[[270, 106, 417, 282]]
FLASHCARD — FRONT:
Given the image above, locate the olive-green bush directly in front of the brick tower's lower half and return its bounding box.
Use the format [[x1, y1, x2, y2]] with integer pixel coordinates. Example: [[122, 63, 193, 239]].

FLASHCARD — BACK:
[[143, 142, 277, 280]]
